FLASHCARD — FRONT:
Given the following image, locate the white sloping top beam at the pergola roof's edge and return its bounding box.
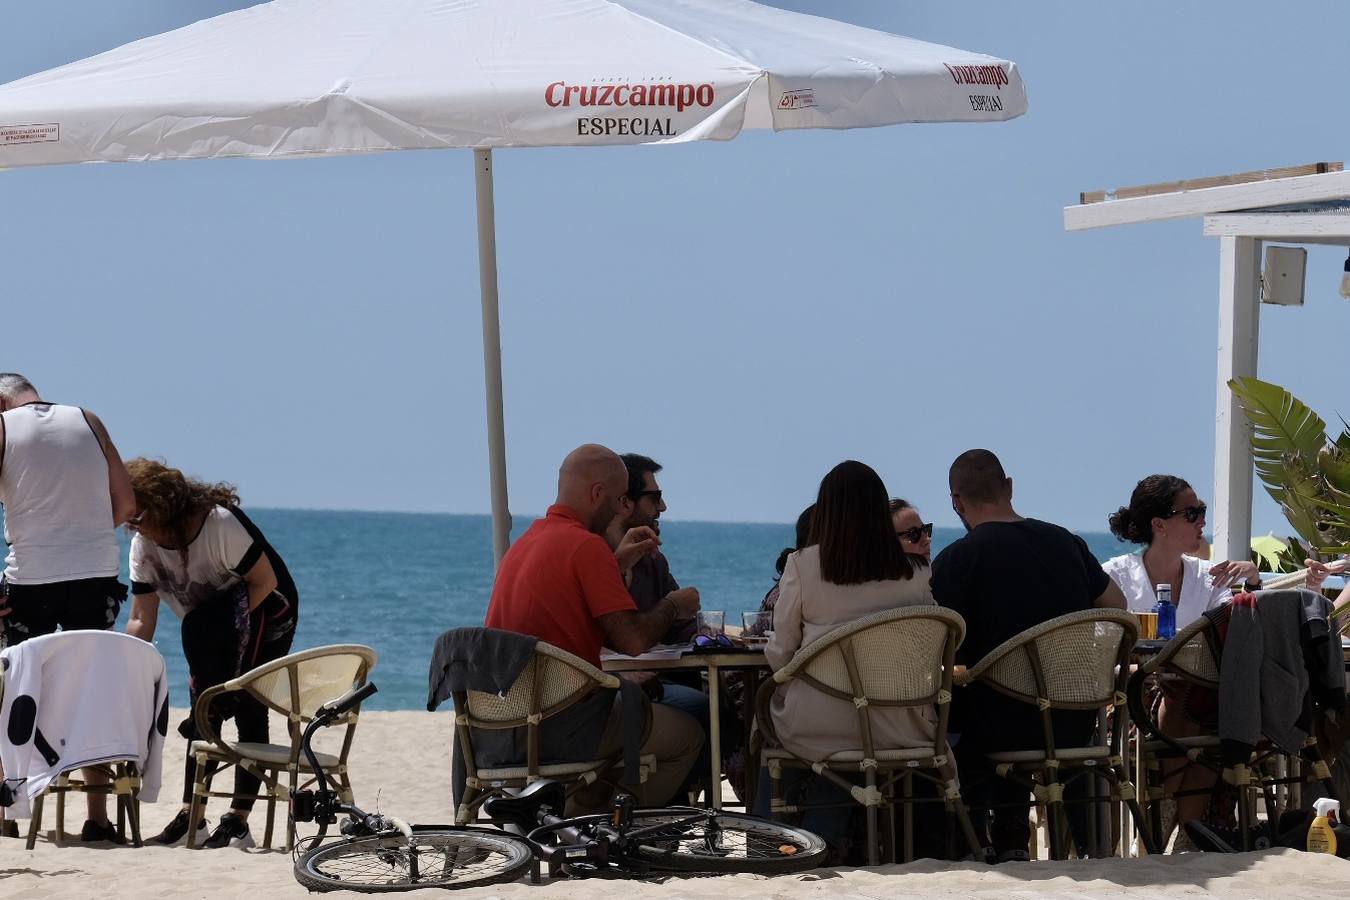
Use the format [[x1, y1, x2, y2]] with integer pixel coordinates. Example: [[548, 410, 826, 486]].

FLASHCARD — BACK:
[[1064, 171, 1350, 231]]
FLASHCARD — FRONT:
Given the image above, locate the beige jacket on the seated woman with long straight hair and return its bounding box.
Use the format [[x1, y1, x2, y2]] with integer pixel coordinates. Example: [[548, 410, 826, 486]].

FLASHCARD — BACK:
[[764, 546, 937, 761]]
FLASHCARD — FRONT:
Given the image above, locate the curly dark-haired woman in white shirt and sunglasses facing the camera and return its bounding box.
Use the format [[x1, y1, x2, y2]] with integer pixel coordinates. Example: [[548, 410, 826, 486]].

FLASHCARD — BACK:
[[1102, 475, 1261, 629]]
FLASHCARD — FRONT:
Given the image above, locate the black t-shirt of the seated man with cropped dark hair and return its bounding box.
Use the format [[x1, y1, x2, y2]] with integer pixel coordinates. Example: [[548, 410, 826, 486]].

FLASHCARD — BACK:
[[932, 518, 1111, 749]]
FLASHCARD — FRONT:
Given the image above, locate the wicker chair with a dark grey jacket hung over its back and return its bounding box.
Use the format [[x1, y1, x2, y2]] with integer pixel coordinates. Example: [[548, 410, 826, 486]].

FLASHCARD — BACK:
[[1127, 615, 1331, 850]]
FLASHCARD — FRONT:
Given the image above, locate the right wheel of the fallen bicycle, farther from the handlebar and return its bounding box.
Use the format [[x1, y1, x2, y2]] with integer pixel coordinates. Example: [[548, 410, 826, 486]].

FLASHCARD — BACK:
[[628, 808, 826, 874]]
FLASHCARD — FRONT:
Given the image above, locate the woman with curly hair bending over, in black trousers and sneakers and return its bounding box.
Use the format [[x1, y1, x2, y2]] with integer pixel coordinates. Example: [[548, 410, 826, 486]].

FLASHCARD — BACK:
[[127, 459, 300, 847]]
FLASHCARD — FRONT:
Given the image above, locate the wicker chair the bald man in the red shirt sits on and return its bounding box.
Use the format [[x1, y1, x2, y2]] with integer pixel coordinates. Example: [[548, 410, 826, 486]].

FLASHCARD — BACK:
[[451, 641, 656, 824]]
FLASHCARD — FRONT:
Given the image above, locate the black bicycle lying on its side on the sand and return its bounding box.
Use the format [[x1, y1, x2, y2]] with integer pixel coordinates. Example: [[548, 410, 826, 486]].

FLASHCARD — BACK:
[[290, 684, 826, 893]]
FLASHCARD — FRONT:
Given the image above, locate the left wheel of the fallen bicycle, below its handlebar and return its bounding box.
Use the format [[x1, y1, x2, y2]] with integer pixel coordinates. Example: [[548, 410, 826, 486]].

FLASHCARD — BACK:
[[296, 826, 532, 893]]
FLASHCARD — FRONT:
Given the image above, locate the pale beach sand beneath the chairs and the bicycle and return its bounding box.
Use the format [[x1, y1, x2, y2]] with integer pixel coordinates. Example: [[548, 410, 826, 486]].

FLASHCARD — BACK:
[[0, 711, 1350, 900]]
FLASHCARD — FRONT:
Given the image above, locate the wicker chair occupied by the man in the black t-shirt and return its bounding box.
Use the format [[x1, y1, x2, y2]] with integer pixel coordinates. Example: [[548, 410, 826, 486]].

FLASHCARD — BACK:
[[959, 610, 1154, 860]]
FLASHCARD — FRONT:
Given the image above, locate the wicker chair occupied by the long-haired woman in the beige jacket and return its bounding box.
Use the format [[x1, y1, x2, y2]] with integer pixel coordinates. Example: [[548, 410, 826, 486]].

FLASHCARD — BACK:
[[756, 606, 980, 865]]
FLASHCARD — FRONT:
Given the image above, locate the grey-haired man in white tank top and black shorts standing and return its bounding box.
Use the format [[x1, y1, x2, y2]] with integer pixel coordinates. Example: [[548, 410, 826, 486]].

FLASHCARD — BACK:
[[0, 372, 136, 841]]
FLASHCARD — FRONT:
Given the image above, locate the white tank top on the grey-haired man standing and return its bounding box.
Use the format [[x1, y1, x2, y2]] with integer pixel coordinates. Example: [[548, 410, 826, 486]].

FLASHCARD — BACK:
[[0, 403, 117, 584]]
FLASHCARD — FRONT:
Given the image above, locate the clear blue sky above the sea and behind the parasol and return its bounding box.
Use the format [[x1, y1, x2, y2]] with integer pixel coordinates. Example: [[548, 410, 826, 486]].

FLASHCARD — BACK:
[[0, 0, 1350, 533]]
